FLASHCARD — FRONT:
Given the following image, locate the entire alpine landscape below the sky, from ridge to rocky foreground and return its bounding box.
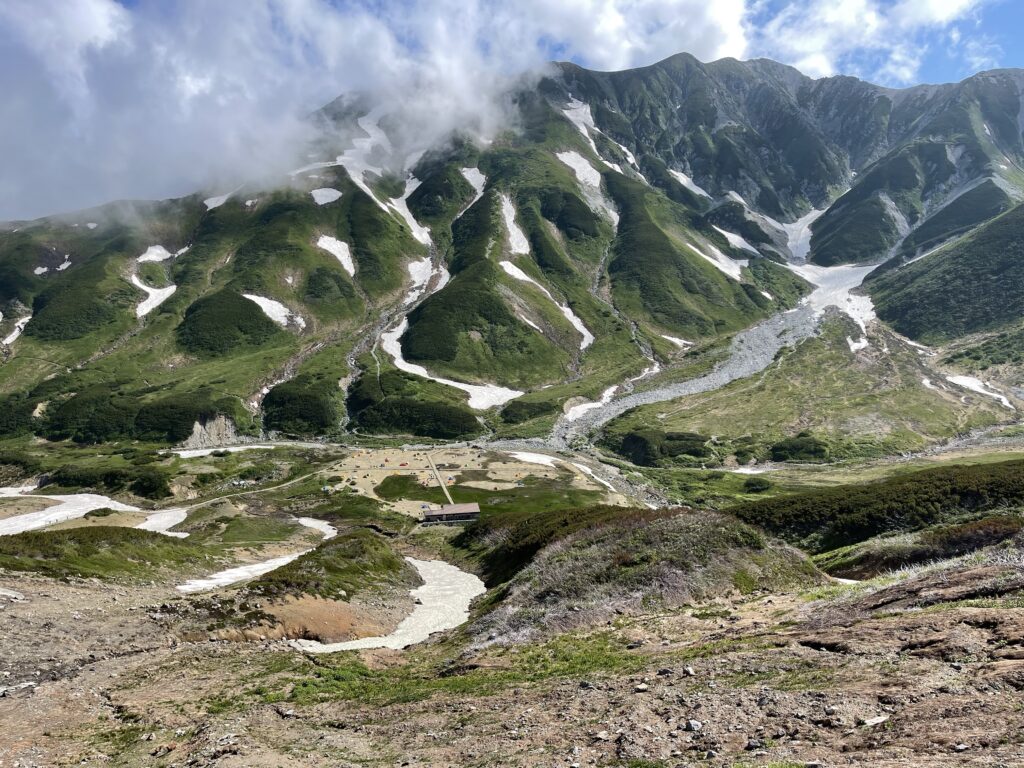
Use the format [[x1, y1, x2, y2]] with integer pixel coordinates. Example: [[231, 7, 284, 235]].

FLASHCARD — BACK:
[[0, 53, 1024, 768]]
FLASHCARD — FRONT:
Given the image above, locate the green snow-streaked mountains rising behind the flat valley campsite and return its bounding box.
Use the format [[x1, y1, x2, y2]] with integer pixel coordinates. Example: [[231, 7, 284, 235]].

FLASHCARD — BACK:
[[0, 54, 1024, 463]]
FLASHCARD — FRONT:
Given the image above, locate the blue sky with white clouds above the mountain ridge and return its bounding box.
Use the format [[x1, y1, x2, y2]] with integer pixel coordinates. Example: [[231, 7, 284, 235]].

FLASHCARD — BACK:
[[0, 0, 1024, 219]]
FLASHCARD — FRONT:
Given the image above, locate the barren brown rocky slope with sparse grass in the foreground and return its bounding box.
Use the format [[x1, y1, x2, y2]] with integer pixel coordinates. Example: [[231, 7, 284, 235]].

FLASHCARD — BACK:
[[0, 561, 1024, 768]]
